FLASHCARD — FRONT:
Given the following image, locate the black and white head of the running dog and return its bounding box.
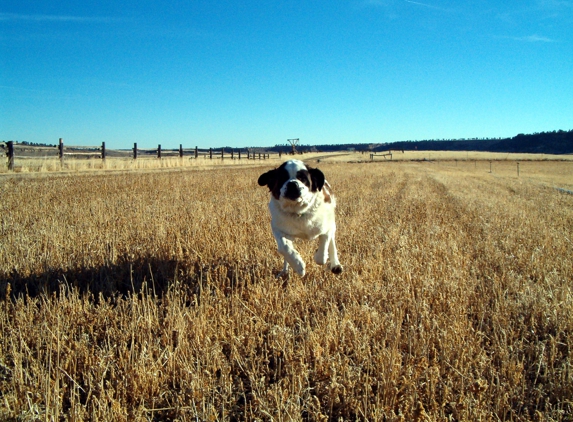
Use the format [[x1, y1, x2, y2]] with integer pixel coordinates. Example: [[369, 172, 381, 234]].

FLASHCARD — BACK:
[[259, 160, 324, 205]]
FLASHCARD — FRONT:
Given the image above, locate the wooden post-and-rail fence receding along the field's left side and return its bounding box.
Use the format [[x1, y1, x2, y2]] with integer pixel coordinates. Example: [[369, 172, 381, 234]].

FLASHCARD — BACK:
[[1, 138, 282, 171]]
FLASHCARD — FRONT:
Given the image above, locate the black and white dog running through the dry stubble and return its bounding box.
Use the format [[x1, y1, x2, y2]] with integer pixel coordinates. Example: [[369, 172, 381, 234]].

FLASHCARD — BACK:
[[258, 160, 343, 277]]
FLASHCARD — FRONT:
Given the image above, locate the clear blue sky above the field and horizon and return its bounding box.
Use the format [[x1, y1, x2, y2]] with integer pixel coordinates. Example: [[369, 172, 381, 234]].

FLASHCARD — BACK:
[[0, 0, 573, 148]]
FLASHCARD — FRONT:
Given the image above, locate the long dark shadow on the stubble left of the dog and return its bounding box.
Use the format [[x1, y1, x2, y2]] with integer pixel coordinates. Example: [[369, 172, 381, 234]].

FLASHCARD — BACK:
[[0, 257, 264, 301]]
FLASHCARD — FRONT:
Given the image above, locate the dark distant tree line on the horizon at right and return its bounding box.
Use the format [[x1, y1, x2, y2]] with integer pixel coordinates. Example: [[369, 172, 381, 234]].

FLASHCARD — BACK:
[[269, 130, 573, 154]]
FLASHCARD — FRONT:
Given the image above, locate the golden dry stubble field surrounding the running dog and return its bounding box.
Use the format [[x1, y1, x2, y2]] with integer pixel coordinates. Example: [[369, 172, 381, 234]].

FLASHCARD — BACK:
[[0, 157, 573, 421]]
